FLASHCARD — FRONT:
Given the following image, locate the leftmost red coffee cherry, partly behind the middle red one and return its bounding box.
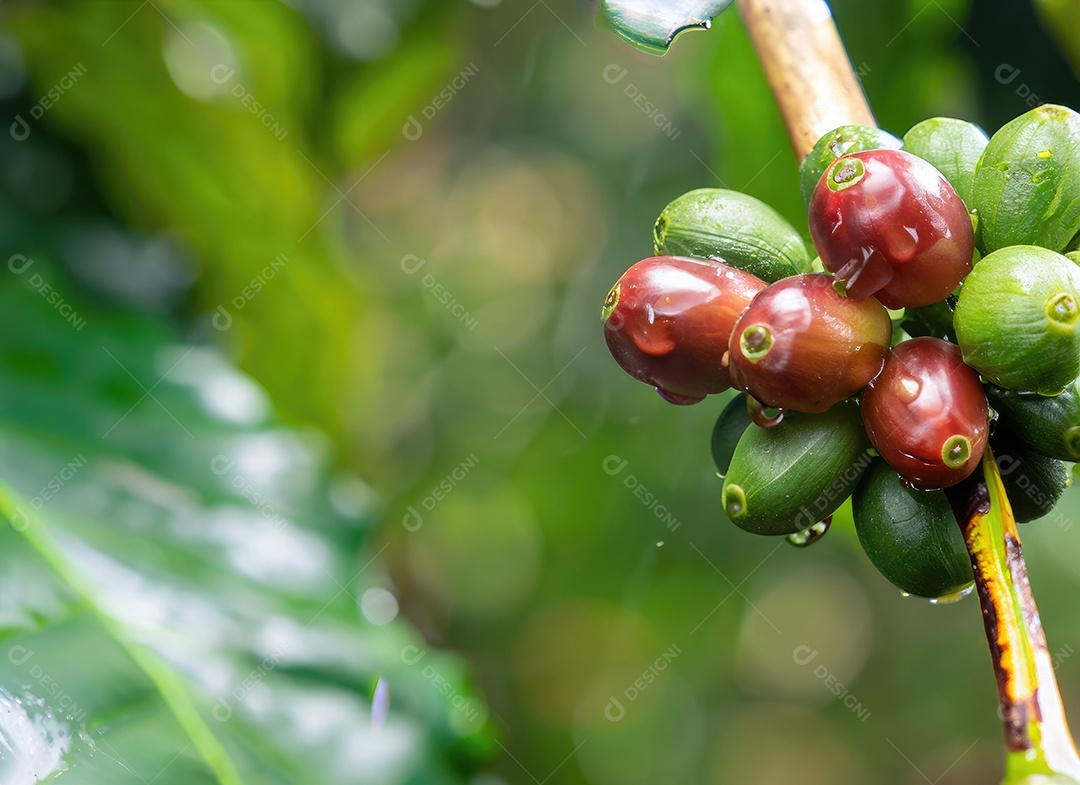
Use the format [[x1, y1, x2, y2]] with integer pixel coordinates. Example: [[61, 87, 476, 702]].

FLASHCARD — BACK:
[[603, 256, 765, 404]]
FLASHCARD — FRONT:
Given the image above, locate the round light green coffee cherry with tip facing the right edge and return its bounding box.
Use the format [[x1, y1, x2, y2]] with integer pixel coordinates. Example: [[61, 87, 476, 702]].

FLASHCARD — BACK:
[[954, 245, 1080, 393]]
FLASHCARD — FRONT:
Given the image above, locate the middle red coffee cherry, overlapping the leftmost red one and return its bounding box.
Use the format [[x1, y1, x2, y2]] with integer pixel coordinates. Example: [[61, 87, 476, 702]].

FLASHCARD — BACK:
[[728, 273, 892, 412]]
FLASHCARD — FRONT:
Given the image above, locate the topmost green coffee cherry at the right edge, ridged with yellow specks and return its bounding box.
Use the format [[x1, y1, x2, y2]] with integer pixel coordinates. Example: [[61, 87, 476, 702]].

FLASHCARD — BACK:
[[974, 104, 1080, 253]]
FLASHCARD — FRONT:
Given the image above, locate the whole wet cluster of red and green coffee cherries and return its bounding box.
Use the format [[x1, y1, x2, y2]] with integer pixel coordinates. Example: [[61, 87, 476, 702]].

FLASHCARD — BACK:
[[603, 105, 1080, 598]]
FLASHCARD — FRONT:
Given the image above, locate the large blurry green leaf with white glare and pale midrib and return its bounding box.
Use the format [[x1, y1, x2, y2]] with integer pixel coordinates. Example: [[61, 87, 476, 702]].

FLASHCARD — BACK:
[[0, 272, 490, 785]]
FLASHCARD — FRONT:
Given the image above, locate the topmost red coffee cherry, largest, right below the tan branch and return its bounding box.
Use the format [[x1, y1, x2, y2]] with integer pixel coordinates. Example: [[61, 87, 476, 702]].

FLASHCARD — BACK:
[[810, 150, 975, 309]]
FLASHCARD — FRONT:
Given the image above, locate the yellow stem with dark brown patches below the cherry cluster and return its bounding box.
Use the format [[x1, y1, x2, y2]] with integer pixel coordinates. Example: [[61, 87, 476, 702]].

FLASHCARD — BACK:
[[949, 447, 1080, 785]]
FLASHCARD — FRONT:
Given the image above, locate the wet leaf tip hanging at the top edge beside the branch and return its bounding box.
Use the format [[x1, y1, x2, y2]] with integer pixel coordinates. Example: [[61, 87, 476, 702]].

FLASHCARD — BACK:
[[600, 0, 731, 55]]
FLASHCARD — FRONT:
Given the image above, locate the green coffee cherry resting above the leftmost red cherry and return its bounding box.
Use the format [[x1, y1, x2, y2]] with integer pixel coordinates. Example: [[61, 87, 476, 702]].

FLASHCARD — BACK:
[[652, 188, 810, 283]]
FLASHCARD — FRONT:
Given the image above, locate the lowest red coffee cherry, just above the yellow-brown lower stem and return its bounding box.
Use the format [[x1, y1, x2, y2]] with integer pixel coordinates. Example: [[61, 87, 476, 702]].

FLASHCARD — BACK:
[[862, 338, 989, 488]]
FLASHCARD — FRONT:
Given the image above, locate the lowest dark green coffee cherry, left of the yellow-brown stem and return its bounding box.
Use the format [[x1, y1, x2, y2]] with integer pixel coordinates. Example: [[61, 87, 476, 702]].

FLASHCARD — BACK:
[[851, 460, 973, 599]]
